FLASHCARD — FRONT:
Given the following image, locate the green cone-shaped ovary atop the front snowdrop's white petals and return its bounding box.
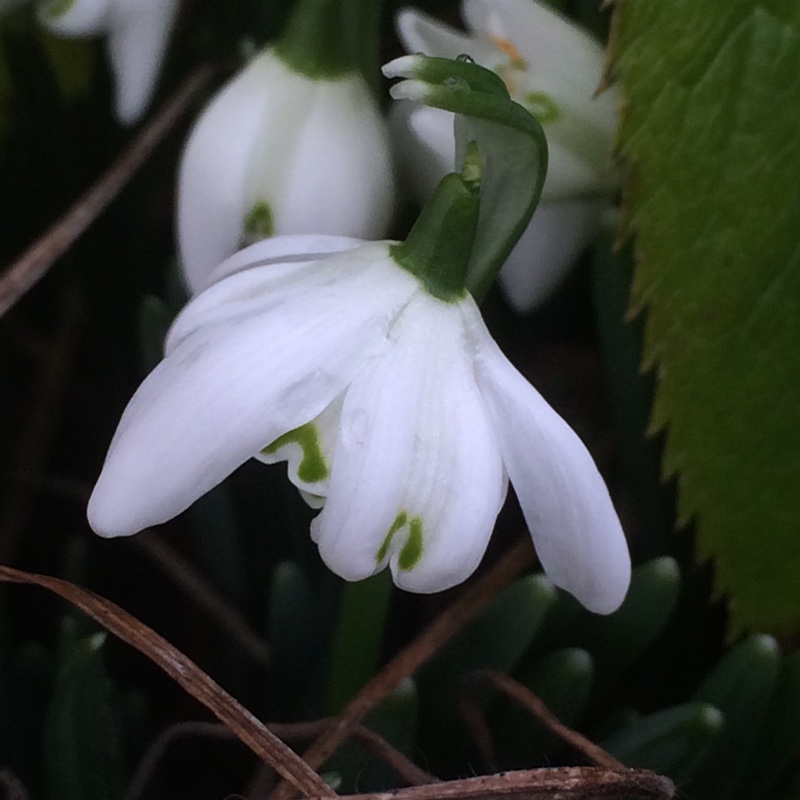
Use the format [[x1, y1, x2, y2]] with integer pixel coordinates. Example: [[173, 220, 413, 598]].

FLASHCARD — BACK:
[[390, 172, 480, 303]]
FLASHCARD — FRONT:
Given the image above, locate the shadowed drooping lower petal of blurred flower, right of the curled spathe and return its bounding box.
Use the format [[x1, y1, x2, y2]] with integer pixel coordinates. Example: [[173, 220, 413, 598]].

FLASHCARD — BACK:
[[500, 200, 608, 314]]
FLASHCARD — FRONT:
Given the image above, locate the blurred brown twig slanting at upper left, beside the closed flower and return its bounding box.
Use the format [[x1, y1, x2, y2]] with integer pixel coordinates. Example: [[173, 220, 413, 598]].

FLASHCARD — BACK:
[[0, 67, 214, 316]]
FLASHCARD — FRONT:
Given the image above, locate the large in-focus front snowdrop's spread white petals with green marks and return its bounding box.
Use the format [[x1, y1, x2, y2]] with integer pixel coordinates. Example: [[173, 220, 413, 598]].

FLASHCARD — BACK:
[[89, 231, 630, 613]]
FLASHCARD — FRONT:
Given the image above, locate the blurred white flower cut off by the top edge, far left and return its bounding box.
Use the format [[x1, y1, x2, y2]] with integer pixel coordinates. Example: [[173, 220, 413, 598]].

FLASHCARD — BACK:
[[39, 0, 179, 125]]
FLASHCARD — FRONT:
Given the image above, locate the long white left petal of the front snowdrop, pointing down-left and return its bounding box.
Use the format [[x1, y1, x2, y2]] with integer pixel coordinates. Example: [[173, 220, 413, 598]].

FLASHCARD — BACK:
[[89, 248, 418, 536]]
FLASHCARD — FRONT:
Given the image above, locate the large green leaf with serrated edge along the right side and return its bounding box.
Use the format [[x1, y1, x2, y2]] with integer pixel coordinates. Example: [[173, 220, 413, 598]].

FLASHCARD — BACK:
[[615, 0, 800, 631]]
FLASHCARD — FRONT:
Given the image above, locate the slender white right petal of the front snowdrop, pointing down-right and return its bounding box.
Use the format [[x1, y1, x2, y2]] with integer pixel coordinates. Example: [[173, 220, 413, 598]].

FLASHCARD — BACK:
[[468, 309, 631, 614]]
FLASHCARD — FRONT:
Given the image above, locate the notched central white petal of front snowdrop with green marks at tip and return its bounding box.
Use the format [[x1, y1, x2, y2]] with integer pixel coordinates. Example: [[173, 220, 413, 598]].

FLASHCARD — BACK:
[[312, 294, 506, 592]]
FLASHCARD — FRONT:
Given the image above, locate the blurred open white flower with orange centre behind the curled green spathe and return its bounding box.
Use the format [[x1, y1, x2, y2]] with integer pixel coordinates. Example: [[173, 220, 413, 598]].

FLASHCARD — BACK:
[[392, 0, 616, 311]]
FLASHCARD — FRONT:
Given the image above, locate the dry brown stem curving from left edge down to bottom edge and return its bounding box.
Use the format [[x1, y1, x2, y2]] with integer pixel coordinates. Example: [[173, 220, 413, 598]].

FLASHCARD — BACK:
[[0, 566, 336, 797]]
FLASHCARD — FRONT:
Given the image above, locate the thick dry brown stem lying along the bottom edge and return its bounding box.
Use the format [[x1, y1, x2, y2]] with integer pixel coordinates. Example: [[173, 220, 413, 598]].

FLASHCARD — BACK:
[[306, 767, 675, 800]]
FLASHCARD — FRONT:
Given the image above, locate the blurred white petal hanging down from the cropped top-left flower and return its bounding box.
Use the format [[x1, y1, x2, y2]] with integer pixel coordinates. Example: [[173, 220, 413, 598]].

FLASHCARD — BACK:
[[108, 0, 178, 125]]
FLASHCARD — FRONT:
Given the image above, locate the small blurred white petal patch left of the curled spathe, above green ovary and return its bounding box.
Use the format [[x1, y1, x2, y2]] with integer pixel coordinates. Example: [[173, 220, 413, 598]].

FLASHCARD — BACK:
[[389, 100, 456, 201]]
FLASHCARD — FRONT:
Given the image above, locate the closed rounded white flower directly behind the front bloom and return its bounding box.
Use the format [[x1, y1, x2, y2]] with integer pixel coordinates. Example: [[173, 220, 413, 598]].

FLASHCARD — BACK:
[[178, 49, 394, 292]]
